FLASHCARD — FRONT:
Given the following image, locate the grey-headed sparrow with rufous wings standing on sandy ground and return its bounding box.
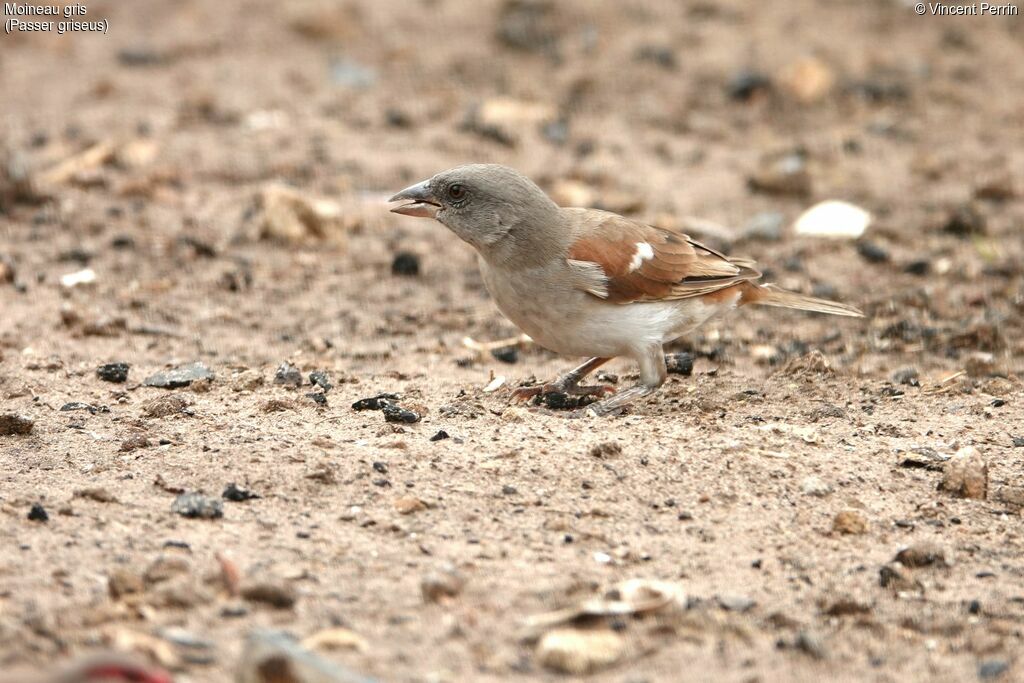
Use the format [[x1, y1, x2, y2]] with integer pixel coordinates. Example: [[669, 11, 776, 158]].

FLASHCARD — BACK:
[[389, 164, 863, 415]]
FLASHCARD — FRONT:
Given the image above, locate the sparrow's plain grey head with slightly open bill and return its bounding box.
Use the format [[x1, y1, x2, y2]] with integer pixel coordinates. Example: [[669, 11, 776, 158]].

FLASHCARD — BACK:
[[389, 164, 560, 260]]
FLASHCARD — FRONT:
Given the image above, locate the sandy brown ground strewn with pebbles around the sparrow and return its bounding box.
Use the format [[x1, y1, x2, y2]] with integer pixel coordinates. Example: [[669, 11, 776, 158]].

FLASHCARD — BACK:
[[0, 0, 1024, 682]]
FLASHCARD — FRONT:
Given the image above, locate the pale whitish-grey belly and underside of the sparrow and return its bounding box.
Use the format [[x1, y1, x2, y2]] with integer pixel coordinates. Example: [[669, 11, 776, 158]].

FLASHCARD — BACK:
[[482, 260, 738, 357]]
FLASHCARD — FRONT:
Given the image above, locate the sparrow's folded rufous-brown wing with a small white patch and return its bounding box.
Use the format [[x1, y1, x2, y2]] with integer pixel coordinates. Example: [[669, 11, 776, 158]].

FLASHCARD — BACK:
[[564, 209, 761, 303]]
